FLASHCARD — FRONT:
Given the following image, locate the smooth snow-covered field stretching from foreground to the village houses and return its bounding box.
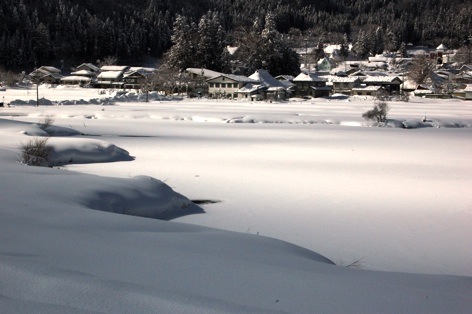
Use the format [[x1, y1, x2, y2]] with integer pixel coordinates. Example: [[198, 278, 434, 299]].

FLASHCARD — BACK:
[[0, 88, 472, 313]]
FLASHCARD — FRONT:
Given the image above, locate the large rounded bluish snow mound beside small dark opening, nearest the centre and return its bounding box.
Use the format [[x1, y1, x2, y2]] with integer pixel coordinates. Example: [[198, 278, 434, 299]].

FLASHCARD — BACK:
[[83, 176, 203, 220]]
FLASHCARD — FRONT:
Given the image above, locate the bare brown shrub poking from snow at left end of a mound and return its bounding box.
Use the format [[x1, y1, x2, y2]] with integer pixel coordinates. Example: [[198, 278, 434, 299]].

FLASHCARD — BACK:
[[20, 137, 50, 167]]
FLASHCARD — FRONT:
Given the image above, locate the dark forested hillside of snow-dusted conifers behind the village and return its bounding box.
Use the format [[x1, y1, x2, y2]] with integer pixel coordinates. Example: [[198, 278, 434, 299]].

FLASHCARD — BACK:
[[0, 0, 472, 70]]
